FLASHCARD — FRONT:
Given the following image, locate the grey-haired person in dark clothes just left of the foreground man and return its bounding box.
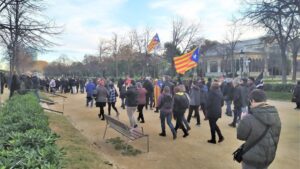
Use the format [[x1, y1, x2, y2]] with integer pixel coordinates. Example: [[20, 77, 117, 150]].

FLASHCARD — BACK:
[[229, 78, 242, 127]]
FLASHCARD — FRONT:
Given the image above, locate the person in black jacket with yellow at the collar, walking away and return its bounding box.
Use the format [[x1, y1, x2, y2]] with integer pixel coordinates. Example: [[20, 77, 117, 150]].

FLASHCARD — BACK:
[[173, 86, 189, 137]]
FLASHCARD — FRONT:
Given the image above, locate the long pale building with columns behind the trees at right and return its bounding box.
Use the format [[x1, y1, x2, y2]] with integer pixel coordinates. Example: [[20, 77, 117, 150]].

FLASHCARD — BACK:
[[200, 38, 300, 77]]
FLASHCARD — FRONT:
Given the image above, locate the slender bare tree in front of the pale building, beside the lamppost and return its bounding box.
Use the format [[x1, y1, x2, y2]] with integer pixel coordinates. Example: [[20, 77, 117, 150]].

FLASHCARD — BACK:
[[224, 21, 242, 77]]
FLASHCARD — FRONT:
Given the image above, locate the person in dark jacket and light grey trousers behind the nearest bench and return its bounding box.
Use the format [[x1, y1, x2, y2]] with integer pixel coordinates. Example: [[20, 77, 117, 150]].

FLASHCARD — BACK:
[[125, 81, 138, 128]]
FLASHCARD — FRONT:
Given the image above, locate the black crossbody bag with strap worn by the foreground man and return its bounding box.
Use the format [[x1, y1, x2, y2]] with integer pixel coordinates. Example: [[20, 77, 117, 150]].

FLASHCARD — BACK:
[[232, 118, 270, 163]]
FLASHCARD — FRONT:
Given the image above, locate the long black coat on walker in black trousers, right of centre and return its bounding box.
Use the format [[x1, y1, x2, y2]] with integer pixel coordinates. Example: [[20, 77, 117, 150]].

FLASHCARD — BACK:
[[206, 89, 224, 119]]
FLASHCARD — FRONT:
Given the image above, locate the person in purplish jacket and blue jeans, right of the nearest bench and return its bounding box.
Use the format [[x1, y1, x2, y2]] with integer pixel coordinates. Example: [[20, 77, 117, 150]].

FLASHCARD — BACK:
[[157, 86, 177, 140]]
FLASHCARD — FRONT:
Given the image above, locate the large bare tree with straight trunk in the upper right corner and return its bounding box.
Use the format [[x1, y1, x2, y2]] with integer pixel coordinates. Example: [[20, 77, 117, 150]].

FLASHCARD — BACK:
[[243, 0, 300, 83]]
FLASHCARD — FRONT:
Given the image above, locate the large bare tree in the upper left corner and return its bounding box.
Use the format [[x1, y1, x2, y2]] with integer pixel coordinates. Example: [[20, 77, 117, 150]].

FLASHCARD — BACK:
[[0, 0, 61, 97]]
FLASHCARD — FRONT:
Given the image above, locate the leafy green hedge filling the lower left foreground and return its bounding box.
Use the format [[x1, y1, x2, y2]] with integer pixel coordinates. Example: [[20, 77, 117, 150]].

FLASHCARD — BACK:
[[0, 94, 63, 169]]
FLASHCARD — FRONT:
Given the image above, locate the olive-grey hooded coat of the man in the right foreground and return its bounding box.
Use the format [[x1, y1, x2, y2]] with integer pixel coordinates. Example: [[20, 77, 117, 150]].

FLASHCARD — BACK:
[[237, 103, 281, 168]]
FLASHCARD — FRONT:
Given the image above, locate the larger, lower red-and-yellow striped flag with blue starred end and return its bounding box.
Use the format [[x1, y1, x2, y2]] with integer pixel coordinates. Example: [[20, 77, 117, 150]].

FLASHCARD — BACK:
[[173, 48, 200, 74]]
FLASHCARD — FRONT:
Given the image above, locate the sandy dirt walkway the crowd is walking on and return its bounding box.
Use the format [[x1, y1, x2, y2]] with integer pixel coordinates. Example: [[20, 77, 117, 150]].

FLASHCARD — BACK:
[[53, 94, 300, 169]]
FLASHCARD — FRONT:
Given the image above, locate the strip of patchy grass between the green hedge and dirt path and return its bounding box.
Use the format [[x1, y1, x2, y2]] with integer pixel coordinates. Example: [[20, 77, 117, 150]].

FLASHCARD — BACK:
[[46, 113, 113, 169]]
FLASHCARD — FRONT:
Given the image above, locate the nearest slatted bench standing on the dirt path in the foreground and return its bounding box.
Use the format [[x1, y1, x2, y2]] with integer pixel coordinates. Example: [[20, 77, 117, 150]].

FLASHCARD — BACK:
[[103, 114, 149, 152]]
